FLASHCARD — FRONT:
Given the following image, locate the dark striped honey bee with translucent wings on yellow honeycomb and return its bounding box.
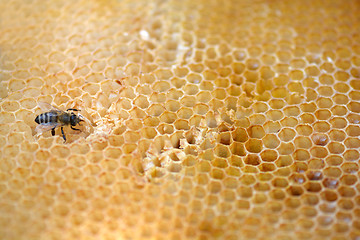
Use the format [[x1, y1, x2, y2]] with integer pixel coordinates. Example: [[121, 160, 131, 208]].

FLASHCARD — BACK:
[[35, 102, 84, 142]]
